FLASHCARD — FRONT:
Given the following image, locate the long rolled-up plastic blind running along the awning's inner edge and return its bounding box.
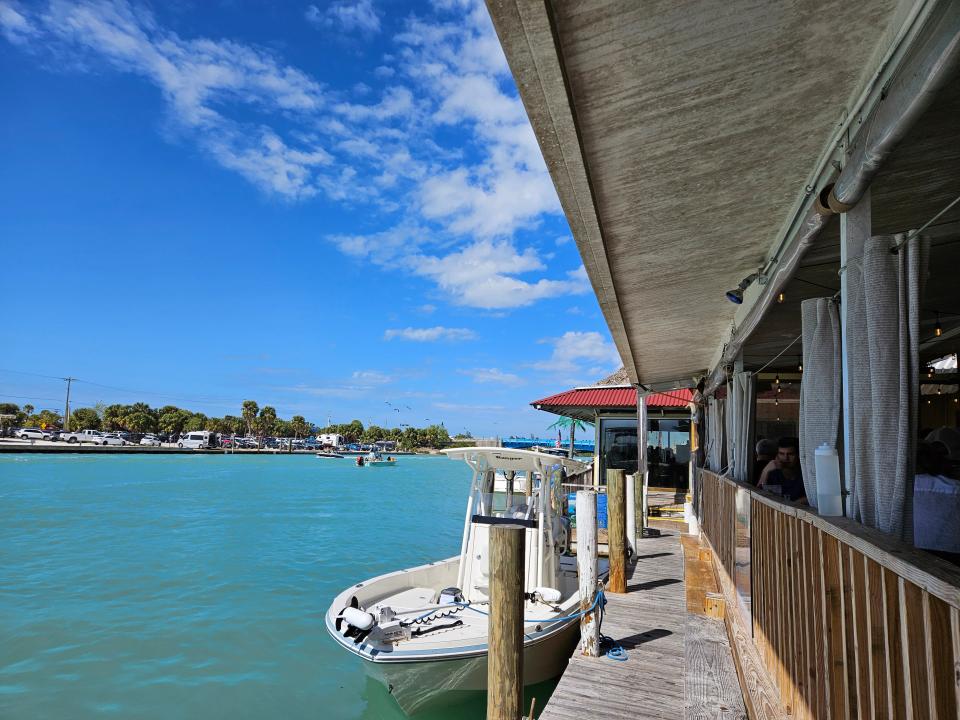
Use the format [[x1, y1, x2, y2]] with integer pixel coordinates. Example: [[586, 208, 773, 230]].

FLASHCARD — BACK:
[[704, 0, 960, 395]]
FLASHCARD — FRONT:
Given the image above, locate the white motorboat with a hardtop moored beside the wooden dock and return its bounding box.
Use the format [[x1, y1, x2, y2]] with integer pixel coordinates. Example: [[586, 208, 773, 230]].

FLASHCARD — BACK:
[[326, 448, 606, 715]]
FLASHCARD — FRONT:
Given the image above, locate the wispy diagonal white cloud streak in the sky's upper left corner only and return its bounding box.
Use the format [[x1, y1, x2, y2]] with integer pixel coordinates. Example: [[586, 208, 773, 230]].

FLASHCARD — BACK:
[[6, 0, 332, 199]]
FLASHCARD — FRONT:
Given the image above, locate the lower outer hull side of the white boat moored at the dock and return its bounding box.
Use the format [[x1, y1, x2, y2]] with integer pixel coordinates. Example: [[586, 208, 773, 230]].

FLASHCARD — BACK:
[[363, 620, 580, 715]]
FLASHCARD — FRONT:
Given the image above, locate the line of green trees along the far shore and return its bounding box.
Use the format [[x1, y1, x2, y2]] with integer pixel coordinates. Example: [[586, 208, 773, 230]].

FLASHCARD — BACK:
[[0, 400, 450, 449]]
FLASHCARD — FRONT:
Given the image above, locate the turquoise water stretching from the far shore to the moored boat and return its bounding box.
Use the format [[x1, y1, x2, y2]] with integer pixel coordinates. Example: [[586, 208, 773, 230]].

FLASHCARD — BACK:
[[0, 455, 548, 720]]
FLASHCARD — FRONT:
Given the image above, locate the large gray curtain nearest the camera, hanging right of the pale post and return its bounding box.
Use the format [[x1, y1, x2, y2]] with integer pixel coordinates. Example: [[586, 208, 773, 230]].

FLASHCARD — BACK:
[[846, 235, 929, 542]]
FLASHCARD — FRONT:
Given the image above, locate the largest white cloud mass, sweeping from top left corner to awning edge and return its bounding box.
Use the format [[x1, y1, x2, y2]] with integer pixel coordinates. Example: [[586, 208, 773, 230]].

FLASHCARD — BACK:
[[0, 0, 576, 309]]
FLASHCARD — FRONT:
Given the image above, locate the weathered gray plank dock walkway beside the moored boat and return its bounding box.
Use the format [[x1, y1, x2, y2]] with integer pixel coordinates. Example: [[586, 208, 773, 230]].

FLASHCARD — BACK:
[[540, 530, 747, 720]]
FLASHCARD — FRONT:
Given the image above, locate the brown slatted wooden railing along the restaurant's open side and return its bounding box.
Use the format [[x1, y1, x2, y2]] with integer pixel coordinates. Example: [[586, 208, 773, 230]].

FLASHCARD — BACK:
[[699, 470, 960, 720]]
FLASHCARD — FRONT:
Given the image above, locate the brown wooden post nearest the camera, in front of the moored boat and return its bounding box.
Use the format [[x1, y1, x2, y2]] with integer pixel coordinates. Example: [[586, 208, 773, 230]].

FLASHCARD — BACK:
[[487, 525, 526, 720]]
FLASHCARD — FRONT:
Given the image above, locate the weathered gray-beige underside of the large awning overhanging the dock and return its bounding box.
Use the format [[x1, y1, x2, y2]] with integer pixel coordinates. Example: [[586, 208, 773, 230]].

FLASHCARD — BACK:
[[488, 0, 929, 389]]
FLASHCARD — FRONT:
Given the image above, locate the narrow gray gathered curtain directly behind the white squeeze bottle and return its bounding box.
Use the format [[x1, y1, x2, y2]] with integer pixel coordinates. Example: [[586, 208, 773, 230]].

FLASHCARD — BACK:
[[800, 298, 843, 507]]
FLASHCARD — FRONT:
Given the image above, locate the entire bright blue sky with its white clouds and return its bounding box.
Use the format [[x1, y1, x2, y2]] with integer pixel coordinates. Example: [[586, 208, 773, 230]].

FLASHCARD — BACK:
[[0, 0, 619, 434]]
